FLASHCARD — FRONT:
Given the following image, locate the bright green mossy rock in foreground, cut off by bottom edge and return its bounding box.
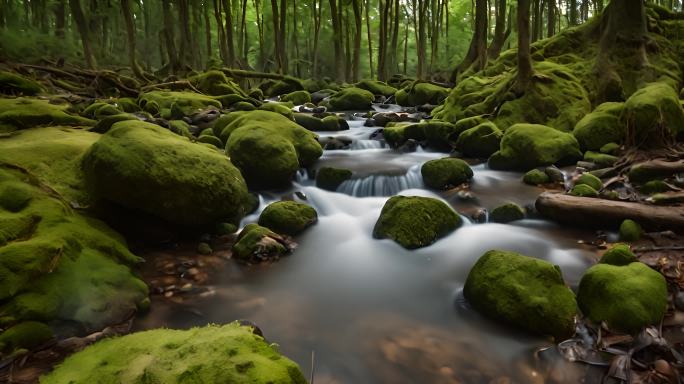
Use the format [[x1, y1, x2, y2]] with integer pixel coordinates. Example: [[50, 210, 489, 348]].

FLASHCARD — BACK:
[[40, 323, 306, 384]]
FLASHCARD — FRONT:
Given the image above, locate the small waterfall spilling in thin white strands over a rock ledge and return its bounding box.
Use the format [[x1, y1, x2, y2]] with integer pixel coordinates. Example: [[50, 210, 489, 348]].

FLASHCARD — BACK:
[[337, 165, 424, 197]]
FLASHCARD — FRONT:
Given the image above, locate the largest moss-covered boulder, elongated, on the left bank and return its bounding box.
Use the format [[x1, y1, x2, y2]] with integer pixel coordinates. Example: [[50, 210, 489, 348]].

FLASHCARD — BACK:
[[82, 121, 250, 226]]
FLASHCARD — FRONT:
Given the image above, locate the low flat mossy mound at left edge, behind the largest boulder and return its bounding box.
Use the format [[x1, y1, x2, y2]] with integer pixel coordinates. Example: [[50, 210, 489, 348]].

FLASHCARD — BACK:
[[0, 97, 95, 133]]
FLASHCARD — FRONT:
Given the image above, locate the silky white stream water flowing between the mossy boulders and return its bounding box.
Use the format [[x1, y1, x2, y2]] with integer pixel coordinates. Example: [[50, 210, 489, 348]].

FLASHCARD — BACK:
[[137, 109, 594, 383]]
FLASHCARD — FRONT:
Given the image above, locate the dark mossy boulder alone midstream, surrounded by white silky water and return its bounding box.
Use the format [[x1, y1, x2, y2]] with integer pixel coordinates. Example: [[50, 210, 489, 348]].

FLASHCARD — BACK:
[[373, 196, 461, 249]]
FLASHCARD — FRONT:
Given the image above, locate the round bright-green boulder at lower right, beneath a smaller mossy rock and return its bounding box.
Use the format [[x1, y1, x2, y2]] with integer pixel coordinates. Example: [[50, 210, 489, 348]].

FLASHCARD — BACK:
[[577, 262, 667, 333]]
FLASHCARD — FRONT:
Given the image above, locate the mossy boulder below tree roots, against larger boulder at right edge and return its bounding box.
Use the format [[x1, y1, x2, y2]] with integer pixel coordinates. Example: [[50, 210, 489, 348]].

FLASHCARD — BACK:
[[572, 103, 625, 151]]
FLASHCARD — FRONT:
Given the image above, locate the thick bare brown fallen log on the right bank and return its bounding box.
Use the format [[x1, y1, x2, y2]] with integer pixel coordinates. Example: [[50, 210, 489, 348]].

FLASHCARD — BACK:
[[535, 192, 684, 231]]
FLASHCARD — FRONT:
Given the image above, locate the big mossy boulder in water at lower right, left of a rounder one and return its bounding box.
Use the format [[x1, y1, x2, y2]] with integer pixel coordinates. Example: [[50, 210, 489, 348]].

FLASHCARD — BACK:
[[463, 250, 577, 341]]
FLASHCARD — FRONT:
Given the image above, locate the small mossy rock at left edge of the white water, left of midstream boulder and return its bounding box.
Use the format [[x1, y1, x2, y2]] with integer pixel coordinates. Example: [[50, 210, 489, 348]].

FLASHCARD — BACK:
[[259, 201, 318, 236]]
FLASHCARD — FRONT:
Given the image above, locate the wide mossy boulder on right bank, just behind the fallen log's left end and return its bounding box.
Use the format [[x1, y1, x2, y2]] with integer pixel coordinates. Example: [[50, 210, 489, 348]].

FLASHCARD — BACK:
[[489, 124, 582, 170]]
